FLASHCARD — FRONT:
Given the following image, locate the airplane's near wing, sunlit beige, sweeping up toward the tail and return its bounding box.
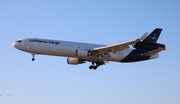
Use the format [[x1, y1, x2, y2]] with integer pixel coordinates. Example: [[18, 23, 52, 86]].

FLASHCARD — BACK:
[[92, 39, 141, 53]]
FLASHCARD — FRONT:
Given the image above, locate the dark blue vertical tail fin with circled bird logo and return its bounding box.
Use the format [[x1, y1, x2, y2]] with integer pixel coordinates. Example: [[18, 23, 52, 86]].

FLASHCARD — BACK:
[[142, 28, 162, 43]]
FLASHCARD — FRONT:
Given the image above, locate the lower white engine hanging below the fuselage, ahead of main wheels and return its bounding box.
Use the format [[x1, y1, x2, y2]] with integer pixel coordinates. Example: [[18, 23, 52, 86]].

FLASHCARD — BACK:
[[67, 57, 85, 65]]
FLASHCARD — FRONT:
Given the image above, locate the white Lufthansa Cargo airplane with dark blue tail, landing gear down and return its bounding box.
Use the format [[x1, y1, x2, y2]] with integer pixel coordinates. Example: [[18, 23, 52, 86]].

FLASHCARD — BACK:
[[12, 28, 166, 70]]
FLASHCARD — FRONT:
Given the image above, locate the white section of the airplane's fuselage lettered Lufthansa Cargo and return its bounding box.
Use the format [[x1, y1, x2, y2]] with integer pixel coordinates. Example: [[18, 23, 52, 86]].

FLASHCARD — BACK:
[[13, 38, 133, 62]]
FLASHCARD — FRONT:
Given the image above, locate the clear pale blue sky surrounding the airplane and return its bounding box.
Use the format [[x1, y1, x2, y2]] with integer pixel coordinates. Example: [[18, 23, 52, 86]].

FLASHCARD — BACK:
[[0, 0, 180, 104]]
